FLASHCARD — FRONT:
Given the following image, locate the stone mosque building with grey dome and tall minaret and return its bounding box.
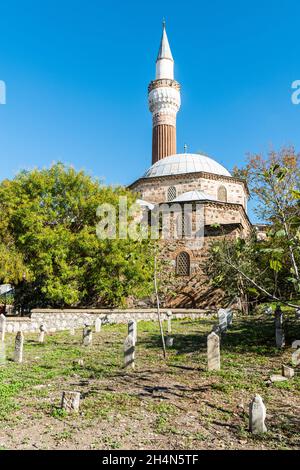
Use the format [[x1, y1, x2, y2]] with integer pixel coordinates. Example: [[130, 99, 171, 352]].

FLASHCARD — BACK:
[[129, 25, 252, 308]]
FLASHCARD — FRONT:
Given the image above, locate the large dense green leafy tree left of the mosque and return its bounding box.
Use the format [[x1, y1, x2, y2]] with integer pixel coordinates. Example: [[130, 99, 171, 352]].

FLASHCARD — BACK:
[[0, 163, 158, 309]]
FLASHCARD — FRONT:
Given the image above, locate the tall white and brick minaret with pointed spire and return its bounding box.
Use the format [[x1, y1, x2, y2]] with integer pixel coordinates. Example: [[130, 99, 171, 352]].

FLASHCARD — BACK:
[[148, 23, 180, 164]]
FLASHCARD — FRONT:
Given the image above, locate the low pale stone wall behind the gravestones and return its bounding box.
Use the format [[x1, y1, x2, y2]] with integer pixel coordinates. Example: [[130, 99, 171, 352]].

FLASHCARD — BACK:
[[0, 309, 215, 333]]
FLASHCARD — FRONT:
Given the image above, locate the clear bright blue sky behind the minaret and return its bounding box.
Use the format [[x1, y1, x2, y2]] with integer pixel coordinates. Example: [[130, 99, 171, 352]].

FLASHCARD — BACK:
[[0, 0, 300, 222]]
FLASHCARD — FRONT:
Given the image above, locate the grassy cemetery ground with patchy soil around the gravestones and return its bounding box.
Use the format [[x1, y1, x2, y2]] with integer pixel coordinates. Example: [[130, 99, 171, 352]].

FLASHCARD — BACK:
[[0, 314, 300, 450]]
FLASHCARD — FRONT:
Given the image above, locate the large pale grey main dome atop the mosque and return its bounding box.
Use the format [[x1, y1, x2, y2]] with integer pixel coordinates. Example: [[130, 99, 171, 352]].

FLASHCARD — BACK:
[[143, 153, 231, 178]]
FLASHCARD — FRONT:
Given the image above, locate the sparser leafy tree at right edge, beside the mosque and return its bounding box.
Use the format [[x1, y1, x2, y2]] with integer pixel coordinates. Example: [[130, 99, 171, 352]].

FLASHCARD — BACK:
[[208, 148, 300, 308]]
